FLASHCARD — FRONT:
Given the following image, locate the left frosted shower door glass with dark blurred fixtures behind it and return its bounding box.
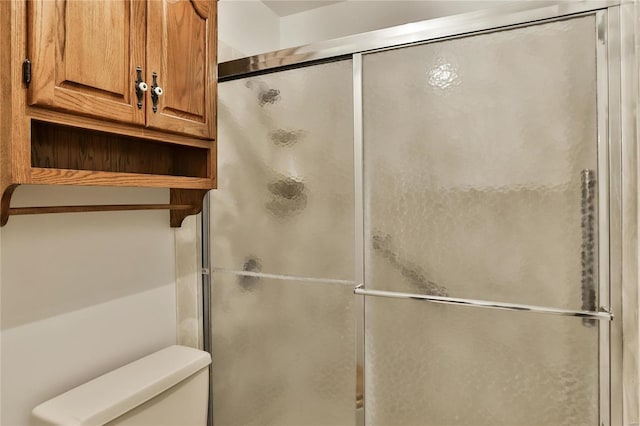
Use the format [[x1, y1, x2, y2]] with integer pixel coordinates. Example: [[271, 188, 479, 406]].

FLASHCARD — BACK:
[[211, 60, 359, 426]]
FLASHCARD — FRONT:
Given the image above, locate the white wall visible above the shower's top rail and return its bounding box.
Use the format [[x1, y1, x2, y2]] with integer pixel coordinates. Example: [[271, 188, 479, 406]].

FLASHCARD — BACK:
[[218, 0, 513, 62]]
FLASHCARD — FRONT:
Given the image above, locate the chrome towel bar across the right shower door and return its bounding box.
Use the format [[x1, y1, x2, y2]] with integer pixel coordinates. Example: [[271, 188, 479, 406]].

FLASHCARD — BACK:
[[353, 284, 613, 321]]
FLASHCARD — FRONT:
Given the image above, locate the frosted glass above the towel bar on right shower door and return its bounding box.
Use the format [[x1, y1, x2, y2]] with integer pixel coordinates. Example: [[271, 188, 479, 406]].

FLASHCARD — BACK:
[[363, 16, 597, 309]]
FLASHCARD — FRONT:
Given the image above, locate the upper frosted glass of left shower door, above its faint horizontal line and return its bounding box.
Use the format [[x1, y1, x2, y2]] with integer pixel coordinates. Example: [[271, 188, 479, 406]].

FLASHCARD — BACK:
[[211, 61, 354, 279]]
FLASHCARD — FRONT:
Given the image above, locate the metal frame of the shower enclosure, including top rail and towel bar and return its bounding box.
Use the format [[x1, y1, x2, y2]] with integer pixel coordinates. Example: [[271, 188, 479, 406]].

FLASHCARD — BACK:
[[212, 0, 640, 426]]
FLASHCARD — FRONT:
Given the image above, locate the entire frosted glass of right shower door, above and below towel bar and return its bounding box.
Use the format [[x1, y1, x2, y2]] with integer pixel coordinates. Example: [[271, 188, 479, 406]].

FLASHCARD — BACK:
[[362, 15, 599, 426]]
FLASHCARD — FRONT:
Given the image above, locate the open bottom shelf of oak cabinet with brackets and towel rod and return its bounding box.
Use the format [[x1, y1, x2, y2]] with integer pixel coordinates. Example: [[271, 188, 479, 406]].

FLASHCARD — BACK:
[[0, 119, 216, 227]]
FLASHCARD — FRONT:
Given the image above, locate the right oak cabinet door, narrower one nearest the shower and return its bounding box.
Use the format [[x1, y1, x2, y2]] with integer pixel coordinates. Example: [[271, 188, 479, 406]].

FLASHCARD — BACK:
[[146, 0, 217, 138]]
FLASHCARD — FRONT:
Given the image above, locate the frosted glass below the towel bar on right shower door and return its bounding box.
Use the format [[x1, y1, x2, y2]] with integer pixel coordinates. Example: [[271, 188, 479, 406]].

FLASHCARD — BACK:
[[365, 297, 598, 426]]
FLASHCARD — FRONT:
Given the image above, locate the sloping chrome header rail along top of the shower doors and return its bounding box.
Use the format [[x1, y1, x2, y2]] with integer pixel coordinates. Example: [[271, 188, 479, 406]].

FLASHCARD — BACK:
[[218, 0, 620, 81]]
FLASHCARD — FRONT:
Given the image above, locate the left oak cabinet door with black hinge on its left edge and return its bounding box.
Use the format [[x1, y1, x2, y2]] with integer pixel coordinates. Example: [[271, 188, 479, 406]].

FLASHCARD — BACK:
[[28, 0, 145, 124]]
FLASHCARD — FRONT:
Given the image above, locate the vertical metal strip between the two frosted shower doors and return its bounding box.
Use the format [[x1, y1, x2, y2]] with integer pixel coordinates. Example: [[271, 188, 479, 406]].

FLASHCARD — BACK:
[[352, 53, 366, 426]]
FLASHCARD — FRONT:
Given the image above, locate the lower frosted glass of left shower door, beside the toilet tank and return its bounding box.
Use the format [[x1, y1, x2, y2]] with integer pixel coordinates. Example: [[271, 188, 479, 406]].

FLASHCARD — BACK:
[[211, 273, 356, 426]]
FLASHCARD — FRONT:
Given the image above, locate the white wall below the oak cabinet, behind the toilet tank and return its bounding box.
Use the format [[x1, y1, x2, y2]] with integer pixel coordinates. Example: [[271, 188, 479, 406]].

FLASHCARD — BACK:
[[0, 187, 176, 426]]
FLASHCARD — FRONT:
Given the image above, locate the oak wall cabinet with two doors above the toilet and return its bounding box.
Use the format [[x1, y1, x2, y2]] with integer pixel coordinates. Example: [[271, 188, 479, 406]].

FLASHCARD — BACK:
[[0, 0, 217, 226]]
